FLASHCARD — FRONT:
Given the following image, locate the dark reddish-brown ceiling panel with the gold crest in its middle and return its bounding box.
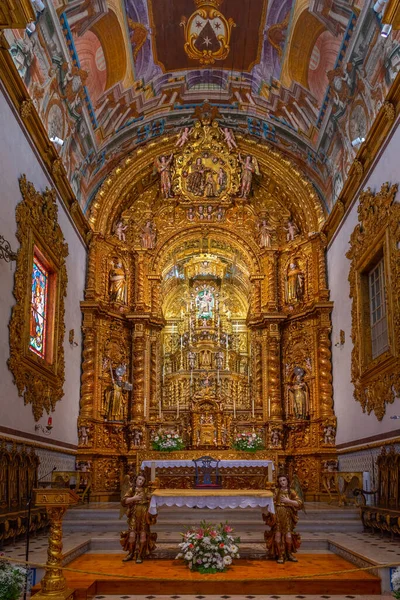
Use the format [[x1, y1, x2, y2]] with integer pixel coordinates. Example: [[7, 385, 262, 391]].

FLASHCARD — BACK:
[[145, 0, 268, 72]]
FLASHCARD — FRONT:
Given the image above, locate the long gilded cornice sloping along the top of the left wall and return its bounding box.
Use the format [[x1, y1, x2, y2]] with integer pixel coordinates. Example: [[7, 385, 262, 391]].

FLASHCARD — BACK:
[[0, 32, 91, 243]]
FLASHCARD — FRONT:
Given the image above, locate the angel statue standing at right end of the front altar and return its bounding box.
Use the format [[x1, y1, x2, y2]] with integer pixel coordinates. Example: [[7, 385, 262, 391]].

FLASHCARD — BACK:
[[263, 475, 304, 564]]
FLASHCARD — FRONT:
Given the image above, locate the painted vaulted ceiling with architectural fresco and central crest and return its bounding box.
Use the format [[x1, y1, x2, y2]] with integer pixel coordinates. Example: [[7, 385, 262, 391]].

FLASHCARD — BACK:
[[6, 0, 400, 212]]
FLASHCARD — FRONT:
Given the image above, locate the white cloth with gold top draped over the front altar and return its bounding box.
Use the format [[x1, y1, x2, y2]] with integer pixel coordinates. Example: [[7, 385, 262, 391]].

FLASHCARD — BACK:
[[149, 489, 275, 515]]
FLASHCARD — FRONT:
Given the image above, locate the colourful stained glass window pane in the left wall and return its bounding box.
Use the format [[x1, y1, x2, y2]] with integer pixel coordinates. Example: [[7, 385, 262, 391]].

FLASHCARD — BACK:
[[29, 256, 49, 358]]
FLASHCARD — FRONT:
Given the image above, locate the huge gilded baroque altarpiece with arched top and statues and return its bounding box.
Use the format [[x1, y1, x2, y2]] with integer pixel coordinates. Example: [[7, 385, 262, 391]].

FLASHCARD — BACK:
[[78, 119, 336, 499]]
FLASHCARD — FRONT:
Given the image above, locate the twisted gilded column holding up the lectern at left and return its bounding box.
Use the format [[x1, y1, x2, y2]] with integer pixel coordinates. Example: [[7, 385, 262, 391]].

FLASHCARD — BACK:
[[40, 506, 67, 598]]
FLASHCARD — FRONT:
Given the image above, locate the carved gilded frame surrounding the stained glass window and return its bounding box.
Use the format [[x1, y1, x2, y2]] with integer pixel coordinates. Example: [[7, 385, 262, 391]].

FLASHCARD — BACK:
[[8, 175, 68, 421]]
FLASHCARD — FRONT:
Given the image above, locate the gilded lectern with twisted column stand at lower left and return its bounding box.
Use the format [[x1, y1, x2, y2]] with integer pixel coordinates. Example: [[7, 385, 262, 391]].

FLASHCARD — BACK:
[[34, 488, 79, 600]]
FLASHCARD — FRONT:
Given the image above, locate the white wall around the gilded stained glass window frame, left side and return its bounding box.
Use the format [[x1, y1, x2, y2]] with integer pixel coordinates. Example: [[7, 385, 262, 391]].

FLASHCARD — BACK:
[[0, 89, 86, 444]]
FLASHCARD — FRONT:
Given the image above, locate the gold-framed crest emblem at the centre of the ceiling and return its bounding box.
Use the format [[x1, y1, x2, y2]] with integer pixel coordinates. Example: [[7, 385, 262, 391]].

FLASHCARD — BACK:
[[181, 0, 236, 65]]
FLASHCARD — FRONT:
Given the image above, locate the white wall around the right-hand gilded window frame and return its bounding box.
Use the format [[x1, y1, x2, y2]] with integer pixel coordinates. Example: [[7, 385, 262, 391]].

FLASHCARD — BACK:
[[327, 120, 400, 444]]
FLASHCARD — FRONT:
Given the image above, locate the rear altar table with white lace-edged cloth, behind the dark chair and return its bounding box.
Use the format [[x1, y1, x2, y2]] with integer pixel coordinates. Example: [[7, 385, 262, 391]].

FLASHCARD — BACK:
[[140, 458, 274, 489]]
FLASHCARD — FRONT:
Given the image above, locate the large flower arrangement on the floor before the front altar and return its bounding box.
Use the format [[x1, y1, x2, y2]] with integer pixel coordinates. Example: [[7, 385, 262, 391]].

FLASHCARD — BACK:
[[176, 521, 240, 573]]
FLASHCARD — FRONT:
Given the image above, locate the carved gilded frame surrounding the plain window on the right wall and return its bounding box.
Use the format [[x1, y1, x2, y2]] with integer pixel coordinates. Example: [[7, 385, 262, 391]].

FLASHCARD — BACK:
[[346, 183, 400, 421]]
